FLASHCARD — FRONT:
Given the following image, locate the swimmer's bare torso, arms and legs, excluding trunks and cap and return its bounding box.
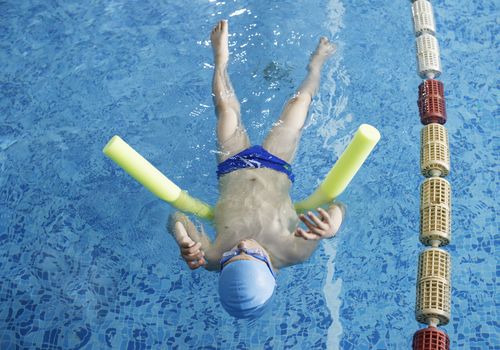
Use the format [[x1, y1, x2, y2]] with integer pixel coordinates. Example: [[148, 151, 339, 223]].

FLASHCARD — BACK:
[[171, 21, 343, 270]]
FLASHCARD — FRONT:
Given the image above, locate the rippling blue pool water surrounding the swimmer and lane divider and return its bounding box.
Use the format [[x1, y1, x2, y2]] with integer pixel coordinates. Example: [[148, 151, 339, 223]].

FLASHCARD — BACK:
[[0, 0, 500, 350]]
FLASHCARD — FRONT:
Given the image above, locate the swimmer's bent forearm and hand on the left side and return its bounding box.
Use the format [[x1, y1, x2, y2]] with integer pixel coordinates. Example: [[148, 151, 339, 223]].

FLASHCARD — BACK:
[[169, 212, 218, 270]]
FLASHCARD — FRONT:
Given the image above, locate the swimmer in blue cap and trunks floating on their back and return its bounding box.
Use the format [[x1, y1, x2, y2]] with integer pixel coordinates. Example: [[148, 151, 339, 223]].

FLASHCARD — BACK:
[[169, 21, 344, 318]]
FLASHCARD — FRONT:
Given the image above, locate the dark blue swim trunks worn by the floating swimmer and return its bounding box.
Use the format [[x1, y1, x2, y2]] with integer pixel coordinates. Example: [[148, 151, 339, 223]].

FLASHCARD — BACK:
[[217, 146, 295, 182]]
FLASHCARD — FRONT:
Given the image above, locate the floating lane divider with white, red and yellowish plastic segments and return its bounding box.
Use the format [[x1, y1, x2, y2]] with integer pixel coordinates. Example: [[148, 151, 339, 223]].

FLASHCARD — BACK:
[[412, 0, 451, 350]]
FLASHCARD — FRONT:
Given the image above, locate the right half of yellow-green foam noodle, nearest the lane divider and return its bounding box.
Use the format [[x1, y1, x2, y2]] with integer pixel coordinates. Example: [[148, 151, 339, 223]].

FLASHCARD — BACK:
[[294, 124, 380, 213]]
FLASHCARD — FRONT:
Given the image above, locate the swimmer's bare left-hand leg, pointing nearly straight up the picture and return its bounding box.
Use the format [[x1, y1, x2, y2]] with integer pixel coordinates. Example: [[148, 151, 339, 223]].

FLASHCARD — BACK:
[[210, 21, 250, 162]]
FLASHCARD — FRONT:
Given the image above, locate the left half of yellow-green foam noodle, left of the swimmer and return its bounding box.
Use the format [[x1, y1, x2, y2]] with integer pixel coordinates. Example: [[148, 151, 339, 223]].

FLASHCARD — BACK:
[[102, 136, 213, 220]]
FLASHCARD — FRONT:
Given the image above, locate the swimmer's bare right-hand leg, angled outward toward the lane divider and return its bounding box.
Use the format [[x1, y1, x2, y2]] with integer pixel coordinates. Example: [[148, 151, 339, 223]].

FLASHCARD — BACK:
[[263, 37, 336, 163]]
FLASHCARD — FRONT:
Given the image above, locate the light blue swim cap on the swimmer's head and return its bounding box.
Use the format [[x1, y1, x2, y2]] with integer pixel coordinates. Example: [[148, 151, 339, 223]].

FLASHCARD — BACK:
[[219, 260, 276, 318]]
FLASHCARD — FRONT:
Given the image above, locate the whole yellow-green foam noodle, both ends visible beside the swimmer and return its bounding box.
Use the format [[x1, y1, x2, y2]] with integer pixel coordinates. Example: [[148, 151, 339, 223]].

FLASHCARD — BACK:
[[103, 124, 380, 220]]
